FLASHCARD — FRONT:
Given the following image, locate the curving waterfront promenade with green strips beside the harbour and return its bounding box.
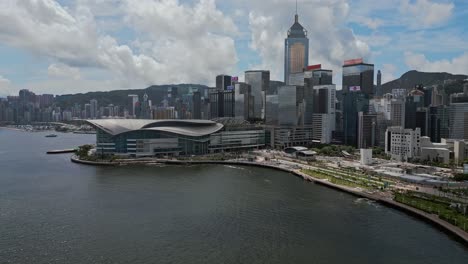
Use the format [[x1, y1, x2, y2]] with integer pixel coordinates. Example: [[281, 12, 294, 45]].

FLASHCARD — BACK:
[[71, 155, 468, 246]]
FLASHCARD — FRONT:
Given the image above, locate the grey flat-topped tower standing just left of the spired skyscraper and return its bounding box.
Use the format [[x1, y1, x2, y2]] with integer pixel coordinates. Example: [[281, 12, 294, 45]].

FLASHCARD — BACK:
[[245, 71, 270, 121]]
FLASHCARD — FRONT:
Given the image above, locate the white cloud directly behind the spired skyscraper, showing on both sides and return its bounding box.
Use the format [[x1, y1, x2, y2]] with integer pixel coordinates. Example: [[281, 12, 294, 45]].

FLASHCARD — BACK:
[[249, 0, 371, 80]]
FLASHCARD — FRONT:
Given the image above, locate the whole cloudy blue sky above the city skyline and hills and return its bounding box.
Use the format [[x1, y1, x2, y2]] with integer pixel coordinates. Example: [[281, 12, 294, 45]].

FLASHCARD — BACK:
[[0, 0, 468, 96]]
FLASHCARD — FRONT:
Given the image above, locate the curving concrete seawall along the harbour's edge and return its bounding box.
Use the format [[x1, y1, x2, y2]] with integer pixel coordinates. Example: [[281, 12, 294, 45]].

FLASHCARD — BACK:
[[71, 156, 468, 246]]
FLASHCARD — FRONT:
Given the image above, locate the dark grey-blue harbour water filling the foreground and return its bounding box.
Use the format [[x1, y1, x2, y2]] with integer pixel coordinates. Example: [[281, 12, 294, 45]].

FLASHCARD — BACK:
[[0, 128, 468, 264]]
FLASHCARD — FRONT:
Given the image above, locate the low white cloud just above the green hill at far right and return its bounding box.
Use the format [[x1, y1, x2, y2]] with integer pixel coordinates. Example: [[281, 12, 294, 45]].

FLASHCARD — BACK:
[[405, 52, 468, 75]]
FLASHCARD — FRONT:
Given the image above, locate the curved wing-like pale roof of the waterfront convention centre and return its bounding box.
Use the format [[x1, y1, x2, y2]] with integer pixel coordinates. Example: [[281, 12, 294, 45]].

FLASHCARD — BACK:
[[86, 119, 223, 137]]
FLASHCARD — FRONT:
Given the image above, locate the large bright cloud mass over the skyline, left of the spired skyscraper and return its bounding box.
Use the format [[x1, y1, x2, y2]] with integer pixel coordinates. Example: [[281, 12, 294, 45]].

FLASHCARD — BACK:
[[125, 0, 238, 84]]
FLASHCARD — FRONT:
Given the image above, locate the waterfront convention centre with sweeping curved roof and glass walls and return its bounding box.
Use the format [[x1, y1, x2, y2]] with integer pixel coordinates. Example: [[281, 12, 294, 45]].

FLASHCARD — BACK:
[[87, 119, 266, 157]]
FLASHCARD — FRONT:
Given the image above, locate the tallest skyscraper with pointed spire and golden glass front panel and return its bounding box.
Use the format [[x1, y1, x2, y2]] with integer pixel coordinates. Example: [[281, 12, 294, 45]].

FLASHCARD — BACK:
[[284, 3, 309, 84]]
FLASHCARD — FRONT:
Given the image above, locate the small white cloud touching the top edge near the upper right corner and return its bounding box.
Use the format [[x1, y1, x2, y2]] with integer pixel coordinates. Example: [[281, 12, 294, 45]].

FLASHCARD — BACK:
[[400, 0, 454, 28]]
